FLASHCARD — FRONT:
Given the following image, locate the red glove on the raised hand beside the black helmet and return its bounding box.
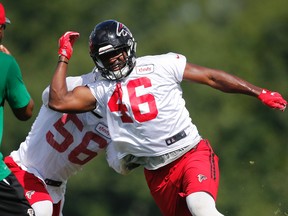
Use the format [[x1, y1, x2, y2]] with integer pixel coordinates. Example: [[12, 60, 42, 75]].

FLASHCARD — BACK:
[[58, 31, 80, 59]]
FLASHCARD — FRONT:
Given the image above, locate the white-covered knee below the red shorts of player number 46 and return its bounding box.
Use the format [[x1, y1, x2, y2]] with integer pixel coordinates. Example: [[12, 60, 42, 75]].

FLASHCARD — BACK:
[[186, 192, 223, 216]]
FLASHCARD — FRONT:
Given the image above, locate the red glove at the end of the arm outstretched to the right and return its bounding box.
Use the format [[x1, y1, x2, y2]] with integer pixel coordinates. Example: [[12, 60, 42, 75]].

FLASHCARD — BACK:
[[258, 89, 287, 111]]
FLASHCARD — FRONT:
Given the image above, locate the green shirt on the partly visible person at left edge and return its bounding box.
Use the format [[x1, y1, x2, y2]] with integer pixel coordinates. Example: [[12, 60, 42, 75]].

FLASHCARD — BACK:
[[0, 52, 30, 180]]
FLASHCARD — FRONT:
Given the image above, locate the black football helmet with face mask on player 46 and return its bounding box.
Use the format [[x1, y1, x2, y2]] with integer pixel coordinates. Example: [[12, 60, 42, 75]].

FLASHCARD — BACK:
[[89, 20, 136, 80]]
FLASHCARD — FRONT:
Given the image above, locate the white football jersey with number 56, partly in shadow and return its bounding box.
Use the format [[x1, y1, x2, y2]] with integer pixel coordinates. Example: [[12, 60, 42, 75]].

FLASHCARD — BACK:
[[11, 72, 110, 202]]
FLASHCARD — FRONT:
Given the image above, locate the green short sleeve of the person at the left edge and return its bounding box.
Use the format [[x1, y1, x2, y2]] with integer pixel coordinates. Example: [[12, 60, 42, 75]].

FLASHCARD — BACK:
[[6, 57, 31, 109]]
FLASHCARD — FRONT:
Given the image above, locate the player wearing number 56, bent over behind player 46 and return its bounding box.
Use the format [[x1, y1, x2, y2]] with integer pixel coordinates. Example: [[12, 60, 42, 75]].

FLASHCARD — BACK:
[[5, 71, 117, 216]]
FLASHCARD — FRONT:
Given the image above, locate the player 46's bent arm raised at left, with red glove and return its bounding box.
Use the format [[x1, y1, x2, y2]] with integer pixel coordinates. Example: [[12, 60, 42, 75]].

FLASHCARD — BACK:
[[48, 32, 96, 113]]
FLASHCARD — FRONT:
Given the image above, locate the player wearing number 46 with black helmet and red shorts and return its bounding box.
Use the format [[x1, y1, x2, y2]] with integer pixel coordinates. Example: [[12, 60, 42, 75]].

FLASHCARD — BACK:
[[49, 20, 287, 216]]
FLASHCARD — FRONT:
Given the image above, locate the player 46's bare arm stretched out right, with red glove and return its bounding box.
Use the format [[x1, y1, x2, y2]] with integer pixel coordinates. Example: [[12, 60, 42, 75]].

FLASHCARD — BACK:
[[183, 63, 287, 111]]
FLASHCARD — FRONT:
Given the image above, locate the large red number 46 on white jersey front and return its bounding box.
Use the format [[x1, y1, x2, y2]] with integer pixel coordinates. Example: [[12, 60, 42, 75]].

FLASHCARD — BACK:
[[108, 77, 158, 123]]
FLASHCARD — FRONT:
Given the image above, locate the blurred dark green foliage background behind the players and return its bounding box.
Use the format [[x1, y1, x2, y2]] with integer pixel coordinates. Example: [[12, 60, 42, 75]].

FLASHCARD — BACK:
[[2, 0, 288, 216]]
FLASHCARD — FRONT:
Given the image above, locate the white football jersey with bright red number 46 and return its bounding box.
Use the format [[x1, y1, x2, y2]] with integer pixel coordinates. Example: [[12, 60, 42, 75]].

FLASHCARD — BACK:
[[88, 53, 201, 159]]
